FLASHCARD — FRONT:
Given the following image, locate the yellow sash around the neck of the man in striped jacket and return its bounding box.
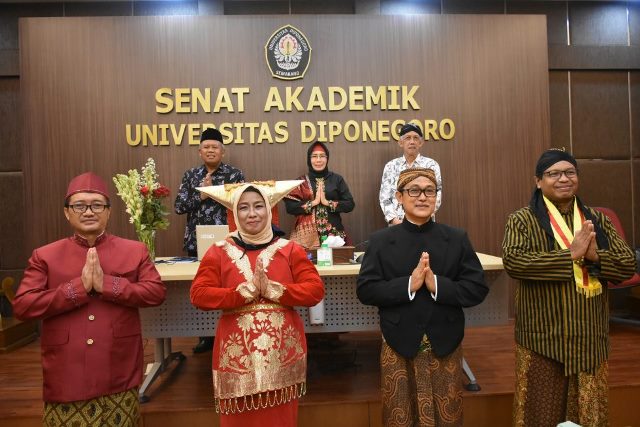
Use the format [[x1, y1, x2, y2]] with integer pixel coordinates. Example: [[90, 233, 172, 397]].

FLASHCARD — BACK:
[[542, 196, 602, 298]]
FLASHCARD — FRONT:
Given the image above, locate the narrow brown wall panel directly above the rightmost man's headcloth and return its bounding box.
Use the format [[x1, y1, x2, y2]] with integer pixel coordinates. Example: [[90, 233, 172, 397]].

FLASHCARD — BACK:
[[549, 71, 571, 150]]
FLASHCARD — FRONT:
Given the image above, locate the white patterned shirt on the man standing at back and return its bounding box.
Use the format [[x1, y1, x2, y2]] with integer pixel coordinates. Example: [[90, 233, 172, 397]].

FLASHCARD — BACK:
[[378, 154, 442, 222]]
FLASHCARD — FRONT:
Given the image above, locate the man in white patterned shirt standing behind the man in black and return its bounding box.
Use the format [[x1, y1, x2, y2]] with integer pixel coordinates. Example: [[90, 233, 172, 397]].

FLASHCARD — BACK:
[[379, 123, 442, 225]]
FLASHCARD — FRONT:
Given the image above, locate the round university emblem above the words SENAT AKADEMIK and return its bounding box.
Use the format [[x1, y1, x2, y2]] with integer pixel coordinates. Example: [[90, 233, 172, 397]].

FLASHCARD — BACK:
[[264, 25, 311, 80]]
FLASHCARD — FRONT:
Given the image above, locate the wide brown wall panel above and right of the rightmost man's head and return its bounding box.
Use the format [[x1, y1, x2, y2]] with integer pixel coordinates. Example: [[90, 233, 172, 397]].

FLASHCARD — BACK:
[[571, 71, 630, 159]]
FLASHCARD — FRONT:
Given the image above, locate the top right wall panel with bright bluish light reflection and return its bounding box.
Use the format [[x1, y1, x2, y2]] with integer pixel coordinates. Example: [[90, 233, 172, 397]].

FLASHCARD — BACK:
[[568, 1, 628, 46]]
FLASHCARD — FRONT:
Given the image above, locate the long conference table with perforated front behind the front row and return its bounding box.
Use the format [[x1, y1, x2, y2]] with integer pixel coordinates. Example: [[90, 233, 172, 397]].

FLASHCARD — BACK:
[[139, 253, 509, 402]]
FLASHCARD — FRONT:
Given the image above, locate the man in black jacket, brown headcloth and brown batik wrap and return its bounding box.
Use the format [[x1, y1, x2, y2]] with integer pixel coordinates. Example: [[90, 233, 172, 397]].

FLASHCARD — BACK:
[[357, 168, 489, 426]]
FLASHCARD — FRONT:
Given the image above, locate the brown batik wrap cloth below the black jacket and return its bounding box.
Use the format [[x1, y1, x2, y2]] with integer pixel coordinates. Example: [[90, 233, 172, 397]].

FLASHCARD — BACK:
[[380, 341, 462, 427]]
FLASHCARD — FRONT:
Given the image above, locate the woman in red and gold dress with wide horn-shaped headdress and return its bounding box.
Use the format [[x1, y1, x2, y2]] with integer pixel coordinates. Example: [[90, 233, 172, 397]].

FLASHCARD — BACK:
[[191, 181, 324, 427]]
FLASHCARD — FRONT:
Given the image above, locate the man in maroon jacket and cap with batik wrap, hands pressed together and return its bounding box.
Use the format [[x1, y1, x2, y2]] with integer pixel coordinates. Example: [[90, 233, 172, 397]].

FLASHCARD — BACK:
[[13, 172, 165, 426]]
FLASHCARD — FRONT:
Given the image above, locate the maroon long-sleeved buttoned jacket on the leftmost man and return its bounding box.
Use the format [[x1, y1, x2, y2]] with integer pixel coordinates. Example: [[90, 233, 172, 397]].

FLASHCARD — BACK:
[[13, 233, 166, 402]]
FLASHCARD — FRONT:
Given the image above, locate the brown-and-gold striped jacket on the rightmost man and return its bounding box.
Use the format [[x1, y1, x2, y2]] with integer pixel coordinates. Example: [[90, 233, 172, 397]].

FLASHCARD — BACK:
[[502, 207, 635, 375]]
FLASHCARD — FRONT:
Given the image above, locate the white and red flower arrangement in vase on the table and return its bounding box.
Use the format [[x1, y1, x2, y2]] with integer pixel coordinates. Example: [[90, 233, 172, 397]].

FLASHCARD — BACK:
[[113, 157, 169, 260]]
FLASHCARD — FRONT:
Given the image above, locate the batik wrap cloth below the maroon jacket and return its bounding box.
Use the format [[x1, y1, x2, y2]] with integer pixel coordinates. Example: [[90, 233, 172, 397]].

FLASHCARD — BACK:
[[42, 388, 140, 427]]
